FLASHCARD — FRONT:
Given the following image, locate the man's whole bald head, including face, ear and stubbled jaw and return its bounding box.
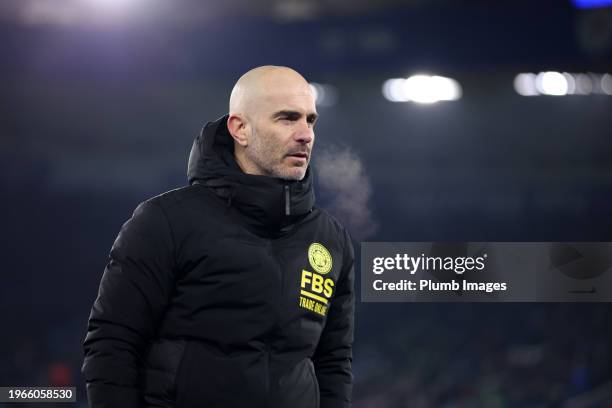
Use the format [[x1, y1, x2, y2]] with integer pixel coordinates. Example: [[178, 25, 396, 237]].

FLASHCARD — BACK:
[[227, 65, 317, 180]]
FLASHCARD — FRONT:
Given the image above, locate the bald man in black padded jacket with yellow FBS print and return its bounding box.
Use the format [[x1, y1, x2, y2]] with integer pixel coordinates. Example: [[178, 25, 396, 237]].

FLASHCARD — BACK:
[[83, 66, 355, 408]]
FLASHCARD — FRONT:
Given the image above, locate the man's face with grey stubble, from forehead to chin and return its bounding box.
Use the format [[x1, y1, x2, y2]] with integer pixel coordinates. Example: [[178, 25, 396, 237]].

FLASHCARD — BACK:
[[245, 84, 317, 180]]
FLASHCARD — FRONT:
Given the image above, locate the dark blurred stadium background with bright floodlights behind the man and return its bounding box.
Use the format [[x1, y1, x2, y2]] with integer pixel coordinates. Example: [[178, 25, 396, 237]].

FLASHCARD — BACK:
[[0, 0, 612, 408]]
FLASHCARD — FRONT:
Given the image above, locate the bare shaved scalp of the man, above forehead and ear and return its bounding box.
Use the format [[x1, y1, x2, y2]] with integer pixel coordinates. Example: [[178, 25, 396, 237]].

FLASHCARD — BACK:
[[229, 65, 312, 117]]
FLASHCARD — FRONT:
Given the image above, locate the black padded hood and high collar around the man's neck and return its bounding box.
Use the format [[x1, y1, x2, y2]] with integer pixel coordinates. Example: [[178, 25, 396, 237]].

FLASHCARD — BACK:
[[187, 115, 314, 231]]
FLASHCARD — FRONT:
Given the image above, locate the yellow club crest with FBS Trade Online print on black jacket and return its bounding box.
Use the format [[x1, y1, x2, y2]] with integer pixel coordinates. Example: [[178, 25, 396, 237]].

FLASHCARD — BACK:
[[299, 242, 334, 316]]
